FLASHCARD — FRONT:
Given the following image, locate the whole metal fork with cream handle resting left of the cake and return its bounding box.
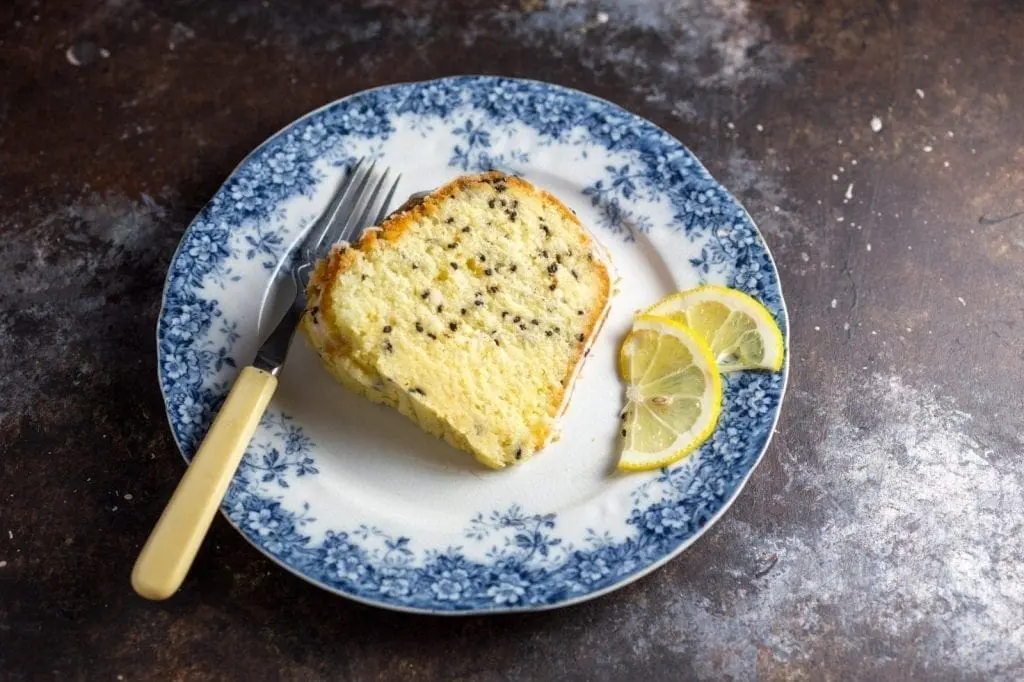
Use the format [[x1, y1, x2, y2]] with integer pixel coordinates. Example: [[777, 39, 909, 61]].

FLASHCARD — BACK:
[[131, 159, 401, 599]]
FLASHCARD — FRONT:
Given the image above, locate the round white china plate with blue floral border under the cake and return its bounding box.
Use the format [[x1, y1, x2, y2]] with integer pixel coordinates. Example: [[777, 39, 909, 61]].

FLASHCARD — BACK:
[[157, 77, 786, 613]]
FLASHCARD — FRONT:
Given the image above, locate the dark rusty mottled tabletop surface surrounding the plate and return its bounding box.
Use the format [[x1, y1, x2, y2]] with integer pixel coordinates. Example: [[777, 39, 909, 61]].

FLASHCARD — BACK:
[[0, 0, 1024, 681]]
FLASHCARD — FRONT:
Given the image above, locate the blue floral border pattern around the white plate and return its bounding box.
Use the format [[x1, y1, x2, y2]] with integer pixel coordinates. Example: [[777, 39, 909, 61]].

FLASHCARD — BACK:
[[158, 77, 786, 612]]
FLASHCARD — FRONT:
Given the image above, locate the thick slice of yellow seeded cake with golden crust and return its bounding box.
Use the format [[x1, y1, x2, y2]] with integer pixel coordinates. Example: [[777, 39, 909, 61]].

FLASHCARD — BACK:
[[302, 172, 610, 469]]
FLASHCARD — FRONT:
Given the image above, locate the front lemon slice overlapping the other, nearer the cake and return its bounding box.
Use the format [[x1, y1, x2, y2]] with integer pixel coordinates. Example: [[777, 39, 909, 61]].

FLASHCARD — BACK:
[[618, 315, 722, 471]]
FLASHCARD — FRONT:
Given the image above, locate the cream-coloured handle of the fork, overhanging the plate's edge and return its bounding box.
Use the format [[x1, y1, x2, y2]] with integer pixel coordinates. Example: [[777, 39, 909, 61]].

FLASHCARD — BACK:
[[131, 367, 278, 599]]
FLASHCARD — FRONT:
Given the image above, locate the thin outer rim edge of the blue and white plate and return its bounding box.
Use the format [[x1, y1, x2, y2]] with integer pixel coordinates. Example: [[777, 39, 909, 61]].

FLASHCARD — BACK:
[[154, 74, 791, 617]]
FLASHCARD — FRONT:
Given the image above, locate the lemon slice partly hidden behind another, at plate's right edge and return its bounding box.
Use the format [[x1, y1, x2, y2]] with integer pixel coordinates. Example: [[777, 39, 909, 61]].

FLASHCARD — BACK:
[[645, 285, 785, 372]]
